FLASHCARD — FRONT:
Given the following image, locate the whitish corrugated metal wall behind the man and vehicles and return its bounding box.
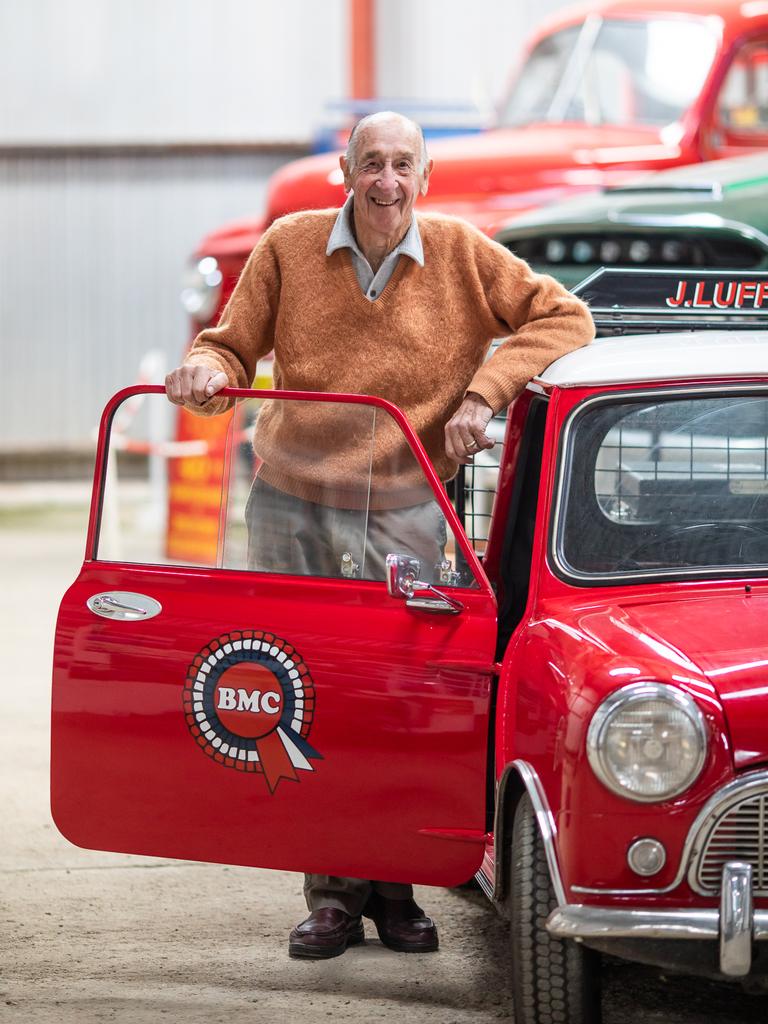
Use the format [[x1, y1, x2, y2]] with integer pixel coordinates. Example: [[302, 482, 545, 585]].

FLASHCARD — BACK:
[[0, 0, 577, 451]]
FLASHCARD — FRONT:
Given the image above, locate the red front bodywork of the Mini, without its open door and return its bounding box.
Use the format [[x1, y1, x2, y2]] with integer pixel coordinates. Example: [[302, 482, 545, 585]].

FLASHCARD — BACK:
[[482, 366, 768, 907]]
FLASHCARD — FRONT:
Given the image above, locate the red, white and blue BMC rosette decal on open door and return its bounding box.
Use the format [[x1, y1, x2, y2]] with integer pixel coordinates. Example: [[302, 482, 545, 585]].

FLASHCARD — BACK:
[[183, 630, 323, 793]]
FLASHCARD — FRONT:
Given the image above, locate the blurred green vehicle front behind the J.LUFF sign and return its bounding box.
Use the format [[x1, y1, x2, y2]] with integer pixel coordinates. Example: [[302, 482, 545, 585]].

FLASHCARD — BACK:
[[495, 150, 768, 288]]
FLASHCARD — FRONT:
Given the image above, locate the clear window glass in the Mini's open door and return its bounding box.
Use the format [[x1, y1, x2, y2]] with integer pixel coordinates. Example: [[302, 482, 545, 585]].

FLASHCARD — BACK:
[[96, 394, 476, 586]]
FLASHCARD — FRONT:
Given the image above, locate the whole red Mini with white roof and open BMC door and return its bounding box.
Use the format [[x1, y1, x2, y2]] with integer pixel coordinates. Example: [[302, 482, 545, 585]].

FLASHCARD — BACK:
[[52, 271, 768, 1024]]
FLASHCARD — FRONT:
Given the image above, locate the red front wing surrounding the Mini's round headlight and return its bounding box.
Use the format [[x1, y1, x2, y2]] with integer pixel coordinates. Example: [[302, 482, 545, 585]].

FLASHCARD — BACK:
[[497, 588, 732, 905]]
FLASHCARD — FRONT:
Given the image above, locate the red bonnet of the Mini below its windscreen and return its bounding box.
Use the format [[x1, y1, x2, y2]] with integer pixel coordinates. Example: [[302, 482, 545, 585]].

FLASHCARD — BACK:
[[582, 584, 768, 768]]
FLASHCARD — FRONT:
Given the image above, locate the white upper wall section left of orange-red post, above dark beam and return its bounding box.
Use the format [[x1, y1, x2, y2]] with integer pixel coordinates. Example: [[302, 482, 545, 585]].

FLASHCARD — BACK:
[[0, 0, 346, 142]]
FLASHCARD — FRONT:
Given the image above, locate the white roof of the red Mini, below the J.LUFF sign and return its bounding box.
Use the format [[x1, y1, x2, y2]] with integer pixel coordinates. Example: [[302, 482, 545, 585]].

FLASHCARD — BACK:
[[535, 330, 768, 387]]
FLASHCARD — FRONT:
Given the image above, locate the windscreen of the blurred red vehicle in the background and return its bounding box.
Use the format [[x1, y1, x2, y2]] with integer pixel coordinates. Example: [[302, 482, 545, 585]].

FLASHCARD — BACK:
[[500, 17, 717, 127]]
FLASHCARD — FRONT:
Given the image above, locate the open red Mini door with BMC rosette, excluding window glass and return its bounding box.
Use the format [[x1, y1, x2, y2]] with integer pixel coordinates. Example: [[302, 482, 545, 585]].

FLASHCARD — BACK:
[[51, 386, 496, 885]]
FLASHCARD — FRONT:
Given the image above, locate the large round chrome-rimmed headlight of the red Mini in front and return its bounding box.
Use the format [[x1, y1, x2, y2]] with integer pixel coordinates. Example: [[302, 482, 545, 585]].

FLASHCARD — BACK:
[[587, 683, 707, 803]]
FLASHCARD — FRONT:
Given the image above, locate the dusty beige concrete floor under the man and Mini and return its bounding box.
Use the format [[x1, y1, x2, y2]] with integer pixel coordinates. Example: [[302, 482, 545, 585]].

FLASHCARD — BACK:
[[0, 496, 768, 1024]]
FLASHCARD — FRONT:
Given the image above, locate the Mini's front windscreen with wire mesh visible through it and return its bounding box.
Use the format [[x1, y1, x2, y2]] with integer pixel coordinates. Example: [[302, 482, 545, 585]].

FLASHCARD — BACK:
[[556, 393, 768, 579]]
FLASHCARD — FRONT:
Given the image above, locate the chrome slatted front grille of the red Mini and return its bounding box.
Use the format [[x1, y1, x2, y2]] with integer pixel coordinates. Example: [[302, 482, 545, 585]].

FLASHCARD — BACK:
[[689, 784, 768, 896]]
